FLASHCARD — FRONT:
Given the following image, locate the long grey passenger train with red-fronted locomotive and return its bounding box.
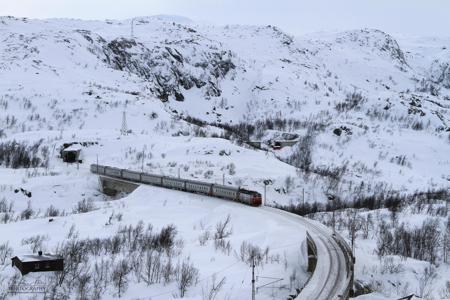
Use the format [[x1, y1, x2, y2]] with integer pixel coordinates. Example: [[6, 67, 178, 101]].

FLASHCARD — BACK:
[[90, 164, 262, 206]]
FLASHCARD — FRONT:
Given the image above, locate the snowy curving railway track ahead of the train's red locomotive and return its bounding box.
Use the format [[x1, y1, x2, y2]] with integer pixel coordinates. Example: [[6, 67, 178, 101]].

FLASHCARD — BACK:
[[91, 167, 353, 300]]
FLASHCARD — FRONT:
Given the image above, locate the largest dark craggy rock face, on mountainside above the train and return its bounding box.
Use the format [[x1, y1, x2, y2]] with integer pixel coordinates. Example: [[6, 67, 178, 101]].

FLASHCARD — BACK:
[[80, 31, 236, 102]]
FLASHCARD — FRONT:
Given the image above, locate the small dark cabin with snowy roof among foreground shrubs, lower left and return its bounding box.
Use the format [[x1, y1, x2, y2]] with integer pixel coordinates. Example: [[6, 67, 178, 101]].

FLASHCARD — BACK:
[[11, 251, 64, 275]]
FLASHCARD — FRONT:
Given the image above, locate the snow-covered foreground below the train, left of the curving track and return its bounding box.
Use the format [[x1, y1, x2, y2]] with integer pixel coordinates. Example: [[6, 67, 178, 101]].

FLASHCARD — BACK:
[[0, 165, 307, 299]]
